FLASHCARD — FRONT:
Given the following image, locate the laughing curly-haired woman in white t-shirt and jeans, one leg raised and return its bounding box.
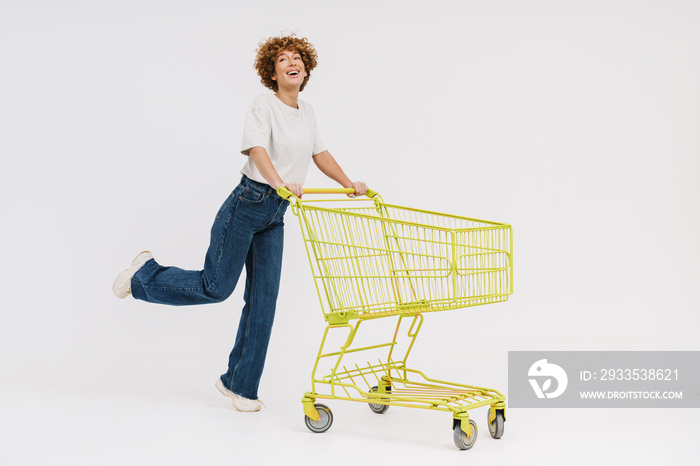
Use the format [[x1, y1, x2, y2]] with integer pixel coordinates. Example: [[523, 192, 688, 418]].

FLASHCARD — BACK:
[[113, 35, 367, 411]]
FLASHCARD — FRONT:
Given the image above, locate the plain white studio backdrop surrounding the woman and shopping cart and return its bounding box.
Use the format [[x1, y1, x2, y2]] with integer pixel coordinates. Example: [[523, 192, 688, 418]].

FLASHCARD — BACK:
[[0, 0, 700, 465]]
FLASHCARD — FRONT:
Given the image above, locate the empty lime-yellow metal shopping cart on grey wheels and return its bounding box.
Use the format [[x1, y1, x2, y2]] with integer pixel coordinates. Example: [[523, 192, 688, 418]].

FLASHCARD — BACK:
[[279, 188, 513, 450]]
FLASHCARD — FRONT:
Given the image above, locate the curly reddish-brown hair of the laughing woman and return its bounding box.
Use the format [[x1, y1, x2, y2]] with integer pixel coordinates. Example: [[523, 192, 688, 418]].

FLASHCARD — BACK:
[[255, 34, 318, 92]]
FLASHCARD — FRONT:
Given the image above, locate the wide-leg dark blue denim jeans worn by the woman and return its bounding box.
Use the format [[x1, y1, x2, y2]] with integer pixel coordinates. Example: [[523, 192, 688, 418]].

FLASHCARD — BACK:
[[131, 176, 289, 400]]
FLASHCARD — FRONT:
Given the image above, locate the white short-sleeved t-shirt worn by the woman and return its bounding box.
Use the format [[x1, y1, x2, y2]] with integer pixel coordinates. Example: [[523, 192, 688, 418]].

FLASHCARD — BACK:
[[241, 94, 326, 184]]
